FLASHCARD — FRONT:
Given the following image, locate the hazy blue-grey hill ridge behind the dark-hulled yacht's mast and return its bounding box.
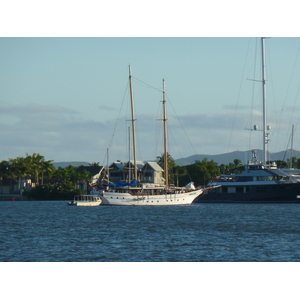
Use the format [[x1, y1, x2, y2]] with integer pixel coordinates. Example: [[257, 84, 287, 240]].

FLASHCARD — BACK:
[[175, 150, 300, 166]]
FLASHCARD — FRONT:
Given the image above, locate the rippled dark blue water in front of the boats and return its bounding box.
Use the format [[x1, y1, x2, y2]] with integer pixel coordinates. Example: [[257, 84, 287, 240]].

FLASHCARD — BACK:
[[0, 201, 300, 262]]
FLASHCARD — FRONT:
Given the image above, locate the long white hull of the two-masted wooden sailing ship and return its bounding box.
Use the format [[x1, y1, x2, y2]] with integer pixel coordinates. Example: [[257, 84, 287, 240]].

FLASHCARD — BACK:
[[102, 189, 203, 205]]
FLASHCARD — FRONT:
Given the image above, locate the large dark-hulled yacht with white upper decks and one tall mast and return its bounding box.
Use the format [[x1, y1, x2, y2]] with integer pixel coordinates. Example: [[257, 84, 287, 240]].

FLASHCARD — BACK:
[[196, 38, 300, 203]]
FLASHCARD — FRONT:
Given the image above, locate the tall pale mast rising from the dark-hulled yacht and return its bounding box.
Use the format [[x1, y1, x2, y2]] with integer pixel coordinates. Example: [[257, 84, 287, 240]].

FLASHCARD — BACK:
[[261, 37, 269, 164]]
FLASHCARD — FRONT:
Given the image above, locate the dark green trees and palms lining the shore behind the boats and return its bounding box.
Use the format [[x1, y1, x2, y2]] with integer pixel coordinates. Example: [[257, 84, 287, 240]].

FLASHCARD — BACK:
[[0, 153, 300, 199]]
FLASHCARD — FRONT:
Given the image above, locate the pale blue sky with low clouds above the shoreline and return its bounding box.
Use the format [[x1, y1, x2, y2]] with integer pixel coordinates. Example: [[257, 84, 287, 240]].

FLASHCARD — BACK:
[[0, 1, 300, 164]]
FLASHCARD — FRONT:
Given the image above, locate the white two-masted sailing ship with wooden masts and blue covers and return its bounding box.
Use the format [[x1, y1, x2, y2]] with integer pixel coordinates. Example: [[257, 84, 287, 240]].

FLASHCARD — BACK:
[[101, 66, 203, 205]]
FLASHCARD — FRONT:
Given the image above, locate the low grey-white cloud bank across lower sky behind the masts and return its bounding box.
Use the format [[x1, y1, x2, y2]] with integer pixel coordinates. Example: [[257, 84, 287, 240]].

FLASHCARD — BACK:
[[0, 103, 298, 164]]
